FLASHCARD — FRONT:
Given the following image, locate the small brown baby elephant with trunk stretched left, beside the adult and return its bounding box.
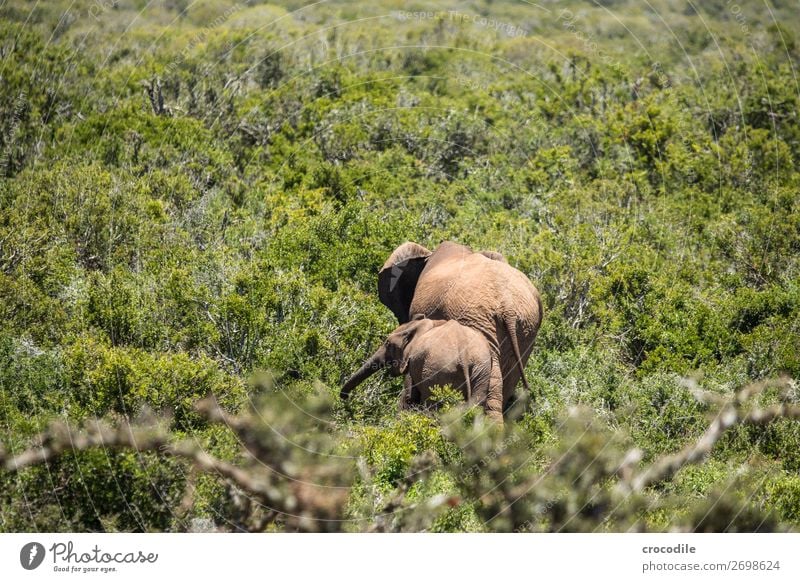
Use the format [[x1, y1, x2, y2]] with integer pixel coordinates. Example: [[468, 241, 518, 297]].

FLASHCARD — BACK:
[[341, 315, 503, 422]]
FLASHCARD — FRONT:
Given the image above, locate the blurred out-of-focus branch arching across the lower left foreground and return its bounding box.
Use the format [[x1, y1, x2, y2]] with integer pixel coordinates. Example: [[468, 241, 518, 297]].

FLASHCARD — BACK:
[[0, 398, 349, 531]]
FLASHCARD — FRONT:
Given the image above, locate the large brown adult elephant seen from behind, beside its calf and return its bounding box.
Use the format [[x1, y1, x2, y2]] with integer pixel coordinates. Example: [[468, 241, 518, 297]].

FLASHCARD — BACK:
[[378, 242, 542, 414]]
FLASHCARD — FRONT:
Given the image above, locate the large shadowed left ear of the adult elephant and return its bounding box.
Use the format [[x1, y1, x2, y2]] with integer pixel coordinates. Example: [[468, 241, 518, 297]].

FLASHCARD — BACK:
[[378, 242, 431, 323]]
